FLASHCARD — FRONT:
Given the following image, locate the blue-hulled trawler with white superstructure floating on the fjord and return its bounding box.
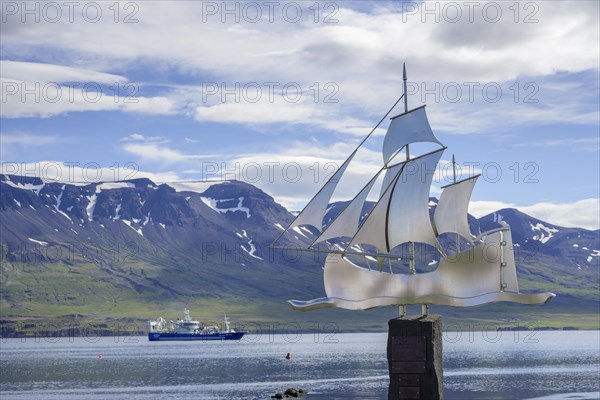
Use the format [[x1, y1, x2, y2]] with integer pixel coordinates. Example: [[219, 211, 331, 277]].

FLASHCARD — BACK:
[[148, 308, 246, 342]]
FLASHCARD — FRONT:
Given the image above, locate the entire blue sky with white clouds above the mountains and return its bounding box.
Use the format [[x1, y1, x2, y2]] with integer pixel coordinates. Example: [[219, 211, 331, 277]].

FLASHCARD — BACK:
[[0, 1, 600, 229]]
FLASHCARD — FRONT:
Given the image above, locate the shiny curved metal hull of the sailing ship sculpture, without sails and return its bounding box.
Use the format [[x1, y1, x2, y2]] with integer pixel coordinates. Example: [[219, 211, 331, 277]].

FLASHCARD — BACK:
[[289, 226, 555, 311]]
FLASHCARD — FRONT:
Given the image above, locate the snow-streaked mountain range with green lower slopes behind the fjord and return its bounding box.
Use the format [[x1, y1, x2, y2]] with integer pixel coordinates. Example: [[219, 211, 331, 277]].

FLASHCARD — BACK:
[[0, 175, 600, 334]]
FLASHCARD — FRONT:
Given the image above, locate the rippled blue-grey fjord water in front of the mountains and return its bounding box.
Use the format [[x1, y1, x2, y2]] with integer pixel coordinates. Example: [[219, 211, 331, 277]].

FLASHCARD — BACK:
[[0, 331, 600, 400]]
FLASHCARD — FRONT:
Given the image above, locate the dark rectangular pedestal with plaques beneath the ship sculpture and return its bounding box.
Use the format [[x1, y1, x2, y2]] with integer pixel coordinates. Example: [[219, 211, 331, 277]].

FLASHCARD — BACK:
[[387, 315, 444, 400]]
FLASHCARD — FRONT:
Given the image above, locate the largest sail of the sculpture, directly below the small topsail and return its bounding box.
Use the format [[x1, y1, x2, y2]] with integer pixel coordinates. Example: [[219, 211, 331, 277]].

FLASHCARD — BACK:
[[347, 148, 445, 253]]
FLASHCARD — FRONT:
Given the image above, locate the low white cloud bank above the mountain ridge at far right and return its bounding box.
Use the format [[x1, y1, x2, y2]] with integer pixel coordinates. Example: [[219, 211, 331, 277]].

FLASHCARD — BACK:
[[469, 199, 600, 230]]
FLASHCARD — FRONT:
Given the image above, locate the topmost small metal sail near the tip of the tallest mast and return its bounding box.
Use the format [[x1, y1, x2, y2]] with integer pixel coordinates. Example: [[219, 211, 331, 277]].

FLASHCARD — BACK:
[[383, 106, 443, 164]]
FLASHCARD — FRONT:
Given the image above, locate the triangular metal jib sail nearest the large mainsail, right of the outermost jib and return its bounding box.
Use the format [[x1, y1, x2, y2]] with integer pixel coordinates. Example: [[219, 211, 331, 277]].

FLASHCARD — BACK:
[[311, 167, 386, 246]]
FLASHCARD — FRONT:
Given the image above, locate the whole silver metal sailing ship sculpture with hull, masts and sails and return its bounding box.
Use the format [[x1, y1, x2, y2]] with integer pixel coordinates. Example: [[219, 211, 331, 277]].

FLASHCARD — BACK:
[[274, 68, 555, 314]]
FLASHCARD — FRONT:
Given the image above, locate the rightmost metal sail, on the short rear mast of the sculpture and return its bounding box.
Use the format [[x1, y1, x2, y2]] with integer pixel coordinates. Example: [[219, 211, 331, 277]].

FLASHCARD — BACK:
[[433, 175, 479, 242]]
